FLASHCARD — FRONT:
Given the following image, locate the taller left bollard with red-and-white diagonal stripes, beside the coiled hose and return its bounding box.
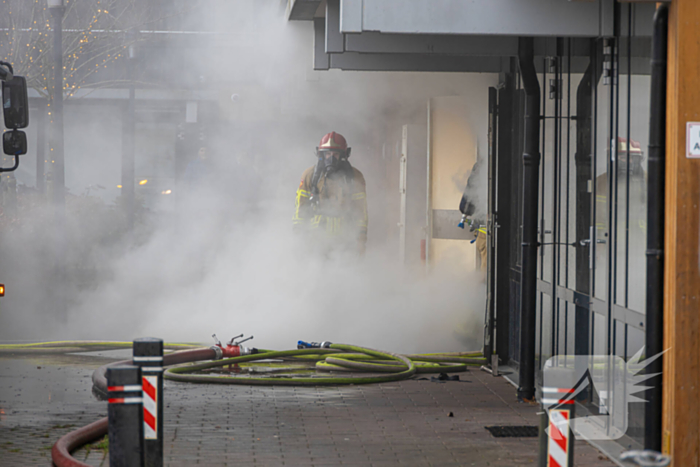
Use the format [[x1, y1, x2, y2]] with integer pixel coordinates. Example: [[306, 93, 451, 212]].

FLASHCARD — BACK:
[[133, 337, 163, 467]]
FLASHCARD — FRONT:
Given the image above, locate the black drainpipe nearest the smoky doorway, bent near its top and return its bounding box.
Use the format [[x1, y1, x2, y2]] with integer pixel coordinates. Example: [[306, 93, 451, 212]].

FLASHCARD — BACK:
[[518, 38, 540, 400]]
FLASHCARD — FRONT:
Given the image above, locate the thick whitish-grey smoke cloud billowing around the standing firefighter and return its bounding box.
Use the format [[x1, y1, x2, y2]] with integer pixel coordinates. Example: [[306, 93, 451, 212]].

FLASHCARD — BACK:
[[0, 0, 492, 353]]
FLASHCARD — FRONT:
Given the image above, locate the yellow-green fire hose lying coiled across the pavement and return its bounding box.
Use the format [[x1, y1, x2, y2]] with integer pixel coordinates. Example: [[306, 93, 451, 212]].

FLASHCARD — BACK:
[[0, 341, 486, 386]]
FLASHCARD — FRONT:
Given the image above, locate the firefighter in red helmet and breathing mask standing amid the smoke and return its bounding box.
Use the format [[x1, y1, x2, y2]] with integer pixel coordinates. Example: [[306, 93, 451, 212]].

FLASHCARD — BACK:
[[293, 131, 367, 255]]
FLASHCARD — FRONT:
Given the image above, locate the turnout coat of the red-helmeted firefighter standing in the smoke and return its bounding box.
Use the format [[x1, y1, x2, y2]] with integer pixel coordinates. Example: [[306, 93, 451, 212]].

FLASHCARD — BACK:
[[293, 166, 367, 245]]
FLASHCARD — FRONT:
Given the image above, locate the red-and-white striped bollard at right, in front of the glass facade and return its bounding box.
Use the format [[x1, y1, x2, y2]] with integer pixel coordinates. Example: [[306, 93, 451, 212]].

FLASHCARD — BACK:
[[540, 387, 576, 467]]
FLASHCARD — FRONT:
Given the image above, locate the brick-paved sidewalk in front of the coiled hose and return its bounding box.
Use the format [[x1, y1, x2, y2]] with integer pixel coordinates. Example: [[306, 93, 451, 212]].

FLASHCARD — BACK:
[[0, 356, 614, 467]]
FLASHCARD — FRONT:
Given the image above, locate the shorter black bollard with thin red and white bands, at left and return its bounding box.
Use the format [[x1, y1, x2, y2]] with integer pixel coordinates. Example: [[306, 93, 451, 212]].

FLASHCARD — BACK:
[[107, 365, 143, 467]]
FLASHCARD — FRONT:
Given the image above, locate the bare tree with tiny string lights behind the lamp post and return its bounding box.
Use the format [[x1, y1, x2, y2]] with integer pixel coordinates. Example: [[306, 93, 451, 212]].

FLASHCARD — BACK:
[[0, 0, 193, 99]]
